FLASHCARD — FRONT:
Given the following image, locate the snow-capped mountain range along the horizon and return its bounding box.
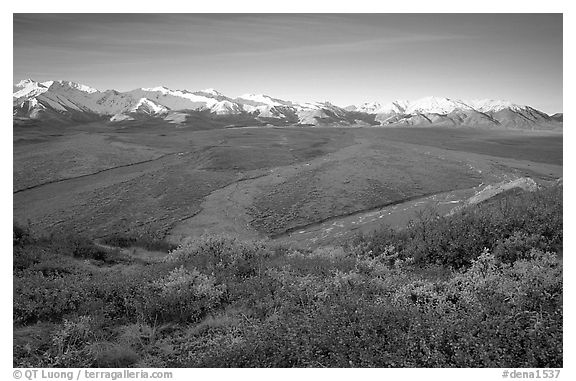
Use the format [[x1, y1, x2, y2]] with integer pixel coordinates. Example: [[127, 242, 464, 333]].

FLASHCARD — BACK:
[[13, 79, 562, 129]]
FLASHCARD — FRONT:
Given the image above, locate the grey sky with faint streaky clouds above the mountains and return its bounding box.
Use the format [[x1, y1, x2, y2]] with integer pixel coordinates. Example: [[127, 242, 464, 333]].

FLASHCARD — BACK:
[[13, 14, 563, 113]]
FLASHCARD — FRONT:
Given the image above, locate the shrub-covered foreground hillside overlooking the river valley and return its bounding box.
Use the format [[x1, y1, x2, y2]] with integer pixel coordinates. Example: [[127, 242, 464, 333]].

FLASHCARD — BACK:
[[13, 185, 563, 368]]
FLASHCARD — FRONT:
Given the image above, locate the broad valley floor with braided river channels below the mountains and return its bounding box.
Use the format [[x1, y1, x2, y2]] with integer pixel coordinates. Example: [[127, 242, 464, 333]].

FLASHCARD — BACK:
[[14, 124, 562, 247]]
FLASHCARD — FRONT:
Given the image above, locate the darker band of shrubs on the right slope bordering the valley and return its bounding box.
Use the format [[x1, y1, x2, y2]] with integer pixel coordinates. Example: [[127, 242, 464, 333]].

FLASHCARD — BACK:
[[352, 186, 563, 269]]
